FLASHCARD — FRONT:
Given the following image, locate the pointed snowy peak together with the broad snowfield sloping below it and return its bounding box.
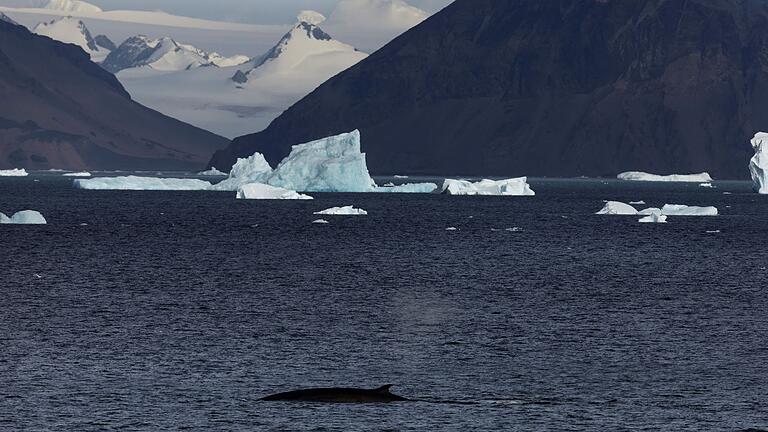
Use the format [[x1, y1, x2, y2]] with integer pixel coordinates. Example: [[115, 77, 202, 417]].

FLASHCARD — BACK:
[[117, 12, 367, 137]]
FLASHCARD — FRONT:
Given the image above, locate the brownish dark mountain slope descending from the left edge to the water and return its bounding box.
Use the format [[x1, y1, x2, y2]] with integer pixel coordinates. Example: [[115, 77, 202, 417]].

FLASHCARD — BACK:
[[0, 21, 226, 169]]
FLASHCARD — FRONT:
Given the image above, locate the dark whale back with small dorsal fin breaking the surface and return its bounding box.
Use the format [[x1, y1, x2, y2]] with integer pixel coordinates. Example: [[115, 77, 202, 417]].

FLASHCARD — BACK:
[[260, 384, 410, 403]]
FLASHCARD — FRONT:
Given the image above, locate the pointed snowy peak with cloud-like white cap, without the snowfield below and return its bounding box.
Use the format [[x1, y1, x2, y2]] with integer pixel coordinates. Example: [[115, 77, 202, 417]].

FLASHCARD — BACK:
[[233, 11, 367, 84]]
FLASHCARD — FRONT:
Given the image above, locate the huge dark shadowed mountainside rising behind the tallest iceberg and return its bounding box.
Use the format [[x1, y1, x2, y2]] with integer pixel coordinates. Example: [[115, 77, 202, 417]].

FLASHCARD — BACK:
[[211, 0, 768, 178]]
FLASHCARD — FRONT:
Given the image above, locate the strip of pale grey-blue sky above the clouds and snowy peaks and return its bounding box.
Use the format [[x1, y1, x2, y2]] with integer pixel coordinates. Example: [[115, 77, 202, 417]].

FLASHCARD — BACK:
[[82, 0, 452, 24]]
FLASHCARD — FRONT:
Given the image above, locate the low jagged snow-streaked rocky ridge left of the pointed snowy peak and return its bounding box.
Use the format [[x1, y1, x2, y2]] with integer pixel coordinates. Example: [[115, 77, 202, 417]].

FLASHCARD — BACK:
[[102, 35, 250, 73]]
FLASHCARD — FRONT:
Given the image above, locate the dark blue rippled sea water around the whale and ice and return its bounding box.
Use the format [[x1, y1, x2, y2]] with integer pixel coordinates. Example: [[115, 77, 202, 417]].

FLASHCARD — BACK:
[[0, 176, 768, 431]]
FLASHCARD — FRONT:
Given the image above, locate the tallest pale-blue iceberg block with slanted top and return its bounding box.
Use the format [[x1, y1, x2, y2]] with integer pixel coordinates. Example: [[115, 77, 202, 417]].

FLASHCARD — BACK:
[[267, 130, 376, 192]]
